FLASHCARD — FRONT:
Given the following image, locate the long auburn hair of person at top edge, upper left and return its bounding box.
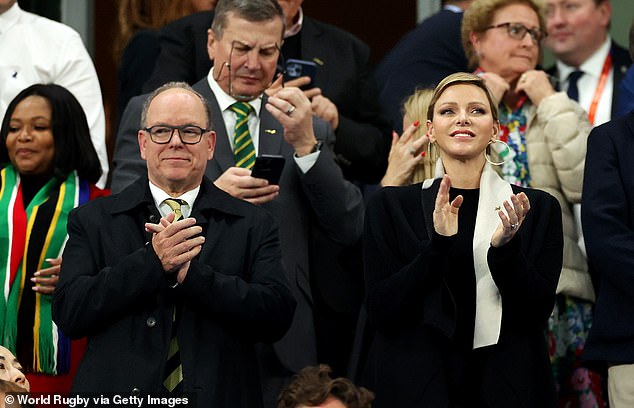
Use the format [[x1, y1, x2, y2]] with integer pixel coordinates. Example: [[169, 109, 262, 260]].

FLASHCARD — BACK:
[[113, 0, 199, 61]]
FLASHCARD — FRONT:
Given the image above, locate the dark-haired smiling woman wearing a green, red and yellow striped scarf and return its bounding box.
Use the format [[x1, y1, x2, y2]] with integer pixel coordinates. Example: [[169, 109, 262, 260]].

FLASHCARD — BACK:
[[0, 84, 104, 392]]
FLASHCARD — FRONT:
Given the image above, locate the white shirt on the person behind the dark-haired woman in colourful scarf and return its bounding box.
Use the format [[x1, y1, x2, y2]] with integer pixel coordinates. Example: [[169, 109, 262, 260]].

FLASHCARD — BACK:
[[0, 2, 108, 187]]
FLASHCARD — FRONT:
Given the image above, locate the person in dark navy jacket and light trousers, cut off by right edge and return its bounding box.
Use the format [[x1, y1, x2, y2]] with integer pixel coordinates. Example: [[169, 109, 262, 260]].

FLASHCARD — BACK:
[[581, 112, 634, 408]]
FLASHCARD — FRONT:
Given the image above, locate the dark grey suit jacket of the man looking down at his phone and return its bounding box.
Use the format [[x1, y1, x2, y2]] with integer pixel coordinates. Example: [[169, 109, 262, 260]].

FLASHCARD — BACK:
[[112, 78, 363, 372]]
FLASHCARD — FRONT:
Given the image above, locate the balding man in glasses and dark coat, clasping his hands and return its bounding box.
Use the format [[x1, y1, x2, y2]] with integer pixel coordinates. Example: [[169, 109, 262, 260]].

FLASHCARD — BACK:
[[53, 83, 295, 408]]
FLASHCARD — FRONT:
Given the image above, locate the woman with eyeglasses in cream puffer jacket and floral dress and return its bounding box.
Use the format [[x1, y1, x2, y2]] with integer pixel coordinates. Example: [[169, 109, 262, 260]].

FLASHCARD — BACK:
[[462, 0, 601, 406]]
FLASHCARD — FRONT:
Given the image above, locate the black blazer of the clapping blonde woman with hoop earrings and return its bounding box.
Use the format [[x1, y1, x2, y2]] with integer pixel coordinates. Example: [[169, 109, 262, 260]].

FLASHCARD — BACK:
[[364, 180, 563, 408]]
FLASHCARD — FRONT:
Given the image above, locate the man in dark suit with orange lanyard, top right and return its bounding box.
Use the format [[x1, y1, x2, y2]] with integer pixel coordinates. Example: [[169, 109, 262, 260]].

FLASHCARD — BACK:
[[545, 0, 632, 126]]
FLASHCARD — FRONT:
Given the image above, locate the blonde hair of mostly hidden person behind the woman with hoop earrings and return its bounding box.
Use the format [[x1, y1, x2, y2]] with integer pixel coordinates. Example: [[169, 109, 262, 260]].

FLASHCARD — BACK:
[[403, 88, 439, 183]]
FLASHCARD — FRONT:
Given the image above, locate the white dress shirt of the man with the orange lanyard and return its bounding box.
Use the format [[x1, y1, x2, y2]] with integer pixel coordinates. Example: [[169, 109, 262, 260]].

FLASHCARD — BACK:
[[557, 36, 614, 126]]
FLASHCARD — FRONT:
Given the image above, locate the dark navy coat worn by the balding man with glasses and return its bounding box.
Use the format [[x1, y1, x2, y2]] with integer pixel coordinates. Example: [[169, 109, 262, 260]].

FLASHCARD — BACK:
[[53, 178, 295, 408]]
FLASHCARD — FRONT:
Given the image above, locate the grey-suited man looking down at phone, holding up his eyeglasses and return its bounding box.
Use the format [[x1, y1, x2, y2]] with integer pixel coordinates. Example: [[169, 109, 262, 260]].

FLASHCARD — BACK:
[[113, 0, 363, 406]]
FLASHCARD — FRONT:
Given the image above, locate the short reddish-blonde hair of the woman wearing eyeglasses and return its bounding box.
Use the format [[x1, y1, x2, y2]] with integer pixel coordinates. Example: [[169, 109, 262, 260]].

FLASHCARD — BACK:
[[461, 0, 546, 69]]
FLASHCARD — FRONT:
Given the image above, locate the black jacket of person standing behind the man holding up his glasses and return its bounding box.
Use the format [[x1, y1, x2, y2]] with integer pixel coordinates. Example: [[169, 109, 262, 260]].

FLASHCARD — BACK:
[[145, 11, 391, 183]]
